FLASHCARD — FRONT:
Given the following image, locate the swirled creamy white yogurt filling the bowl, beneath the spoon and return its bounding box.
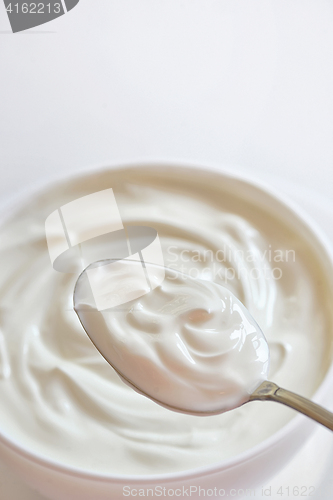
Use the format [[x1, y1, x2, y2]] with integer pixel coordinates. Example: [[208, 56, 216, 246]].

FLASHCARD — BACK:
[[0, 169, 331, 475]]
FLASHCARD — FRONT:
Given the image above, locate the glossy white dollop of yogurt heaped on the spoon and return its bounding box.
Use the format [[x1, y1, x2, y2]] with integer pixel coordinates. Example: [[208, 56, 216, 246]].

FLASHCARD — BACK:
[[74, 262, 269, 415]]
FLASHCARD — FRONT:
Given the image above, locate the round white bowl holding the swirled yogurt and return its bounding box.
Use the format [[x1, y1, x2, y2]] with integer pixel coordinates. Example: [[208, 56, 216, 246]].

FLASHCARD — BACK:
[[0, 164, 333, 500]]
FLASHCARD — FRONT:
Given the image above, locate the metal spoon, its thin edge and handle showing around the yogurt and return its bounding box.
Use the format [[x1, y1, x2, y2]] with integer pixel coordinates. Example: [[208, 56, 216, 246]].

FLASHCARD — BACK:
[[73, 259, 333, 431]]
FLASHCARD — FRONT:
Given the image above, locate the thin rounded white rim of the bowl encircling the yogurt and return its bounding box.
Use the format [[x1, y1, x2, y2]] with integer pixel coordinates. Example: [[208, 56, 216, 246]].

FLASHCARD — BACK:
[[0, 160, 333, 486]]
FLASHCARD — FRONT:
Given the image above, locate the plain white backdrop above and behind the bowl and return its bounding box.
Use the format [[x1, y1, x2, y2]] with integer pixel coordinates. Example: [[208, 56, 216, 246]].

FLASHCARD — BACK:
[[0, 0, 333, 500]]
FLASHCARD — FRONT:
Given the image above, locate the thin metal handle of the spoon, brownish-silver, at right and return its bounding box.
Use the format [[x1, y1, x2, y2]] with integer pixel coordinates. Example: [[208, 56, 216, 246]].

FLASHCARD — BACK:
[[250, 381, 333, 431]]
